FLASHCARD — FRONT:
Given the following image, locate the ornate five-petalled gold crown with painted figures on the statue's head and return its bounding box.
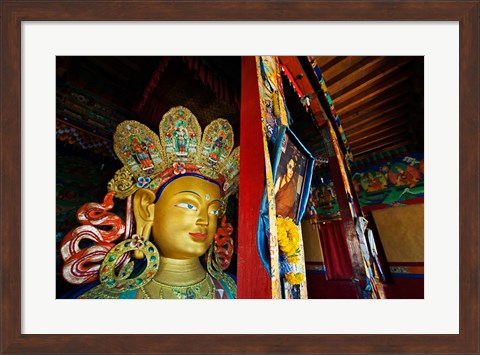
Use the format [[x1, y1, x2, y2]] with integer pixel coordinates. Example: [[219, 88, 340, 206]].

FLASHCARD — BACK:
[[108, 106, 240, 198]]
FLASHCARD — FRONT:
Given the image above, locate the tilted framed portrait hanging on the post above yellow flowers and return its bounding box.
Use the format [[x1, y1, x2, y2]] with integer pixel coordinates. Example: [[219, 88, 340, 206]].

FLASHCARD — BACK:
[[272, 126, 314, 224]]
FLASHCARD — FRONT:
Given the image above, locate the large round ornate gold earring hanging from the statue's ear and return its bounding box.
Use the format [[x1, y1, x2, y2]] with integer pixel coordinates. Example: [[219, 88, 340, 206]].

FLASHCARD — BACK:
[[99, 234, 160, 293]]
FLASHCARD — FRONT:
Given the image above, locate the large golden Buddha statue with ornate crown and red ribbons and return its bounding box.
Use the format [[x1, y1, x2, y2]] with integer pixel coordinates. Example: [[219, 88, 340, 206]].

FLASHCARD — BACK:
[[62, 106, 240, 299]]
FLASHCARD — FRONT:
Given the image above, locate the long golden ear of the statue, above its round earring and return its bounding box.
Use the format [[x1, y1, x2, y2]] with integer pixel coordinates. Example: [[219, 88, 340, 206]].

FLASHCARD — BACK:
[[133, 189, 155, 239]]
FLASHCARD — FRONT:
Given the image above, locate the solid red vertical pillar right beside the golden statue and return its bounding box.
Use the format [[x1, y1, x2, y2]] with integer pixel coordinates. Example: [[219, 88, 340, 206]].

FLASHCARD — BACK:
[[237, 57, 272, 299]]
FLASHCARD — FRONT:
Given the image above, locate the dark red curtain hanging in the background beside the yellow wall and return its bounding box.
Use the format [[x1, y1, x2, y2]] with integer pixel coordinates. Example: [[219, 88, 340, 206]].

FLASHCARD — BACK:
[[318, 221, 353, 280]]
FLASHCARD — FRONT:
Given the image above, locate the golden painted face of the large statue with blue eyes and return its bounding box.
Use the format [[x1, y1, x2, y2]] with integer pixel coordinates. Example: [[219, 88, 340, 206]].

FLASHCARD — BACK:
[[152, 176, 221, 259]]
